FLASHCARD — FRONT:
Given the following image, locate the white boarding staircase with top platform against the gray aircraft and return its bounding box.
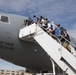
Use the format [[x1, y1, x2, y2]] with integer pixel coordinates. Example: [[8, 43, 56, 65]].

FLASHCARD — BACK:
[[19, 23, 76, 75]]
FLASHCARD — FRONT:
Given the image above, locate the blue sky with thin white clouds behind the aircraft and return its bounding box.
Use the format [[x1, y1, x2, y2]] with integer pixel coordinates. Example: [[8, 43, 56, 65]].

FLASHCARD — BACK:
[[0, 0, 76, 70]]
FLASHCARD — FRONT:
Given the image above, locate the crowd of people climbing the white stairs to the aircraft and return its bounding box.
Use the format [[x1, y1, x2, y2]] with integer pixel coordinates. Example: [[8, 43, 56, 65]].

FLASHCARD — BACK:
[[23, 15, 71, 52]]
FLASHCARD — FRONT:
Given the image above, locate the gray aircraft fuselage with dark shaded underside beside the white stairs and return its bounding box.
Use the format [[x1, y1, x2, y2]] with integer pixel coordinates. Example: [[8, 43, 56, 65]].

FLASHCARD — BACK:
[[0, 14, 52, 71]]
